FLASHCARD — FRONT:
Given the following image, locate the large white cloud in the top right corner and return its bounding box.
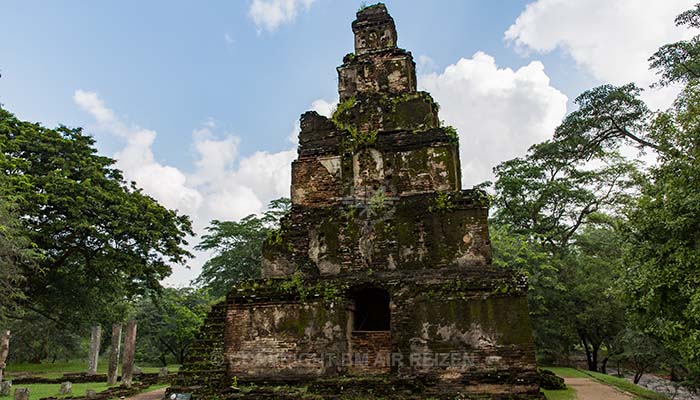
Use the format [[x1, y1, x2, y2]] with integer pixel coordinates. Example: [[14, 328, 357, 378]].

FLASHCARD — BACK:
[[505, 0, 695, 108]]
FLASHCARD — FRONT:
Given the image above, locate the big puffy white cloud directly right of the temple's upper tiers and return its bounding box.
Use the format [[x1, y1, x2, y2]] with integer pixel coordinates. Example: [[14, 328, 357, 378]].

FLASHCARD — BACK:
[[418, 52, 567, 187]]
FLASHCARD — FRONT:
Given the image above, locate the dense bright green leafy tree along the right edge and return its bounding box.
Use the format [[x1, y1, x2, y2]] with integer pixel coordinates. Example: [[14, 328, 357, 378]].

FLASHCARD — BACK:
[[620, 83, 700, 381]]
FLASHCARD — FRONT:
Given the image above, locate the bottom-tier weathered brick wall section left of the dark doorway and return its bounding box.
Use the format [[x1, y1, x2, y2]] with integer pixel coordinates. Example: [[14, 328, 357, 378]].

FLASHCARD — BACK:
[[224, 301, 346, 379]]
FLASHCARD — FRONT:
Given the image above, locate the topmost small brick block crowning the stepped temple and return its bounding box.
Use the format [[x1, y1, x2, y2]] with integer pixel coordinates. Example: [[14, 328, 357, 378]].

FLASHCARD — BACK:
[[352, 3, 397, 55]]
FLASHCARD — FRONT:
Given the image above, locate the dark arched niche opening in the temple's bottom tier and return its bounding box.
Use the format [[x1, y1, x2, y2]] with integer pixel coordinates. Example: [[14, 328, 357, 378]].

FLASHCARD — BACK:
[[353, 288, 391, 331]]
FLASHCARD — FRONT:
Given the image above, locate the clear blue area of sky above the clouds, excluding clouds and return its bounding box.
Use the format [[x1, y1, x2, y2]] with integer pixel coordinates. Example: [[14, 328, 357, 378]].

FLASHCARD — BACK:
[[0, 0, 586, 161]]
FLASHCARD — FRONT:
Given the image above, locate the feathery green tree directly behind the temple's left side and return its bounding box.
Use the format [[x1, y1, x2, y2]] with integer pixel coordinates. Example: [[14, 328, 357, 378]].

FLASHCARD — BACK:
[[194, 198, 291, 297]]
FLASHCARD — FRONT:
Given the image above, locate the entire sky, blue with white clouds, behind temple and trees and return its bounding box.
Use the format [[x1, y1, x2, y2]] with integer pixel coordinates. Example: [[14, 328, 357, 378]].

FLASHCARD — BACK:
[[0, 0, 695, 285]]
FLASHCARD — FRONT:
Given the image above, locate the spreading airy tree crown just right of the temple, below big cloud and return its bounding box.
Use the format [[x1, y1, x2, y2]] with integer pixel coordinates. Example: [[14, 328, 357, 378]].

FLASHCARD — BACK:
[[494, 140, 637, 252]]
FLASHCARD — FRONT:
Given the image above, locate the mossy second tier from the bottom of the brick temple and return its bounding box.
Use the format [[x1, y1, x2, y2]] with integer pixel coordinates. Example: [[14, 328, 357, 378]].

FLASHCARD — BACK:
[[263, 191, 491, 277]]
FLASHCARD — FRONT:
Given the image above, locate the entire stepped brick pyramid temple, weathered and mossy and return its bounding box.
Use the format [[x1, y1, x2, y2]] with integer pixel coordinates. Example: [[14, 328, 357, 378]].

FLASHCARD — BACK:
[[178, 4, 540, 399]]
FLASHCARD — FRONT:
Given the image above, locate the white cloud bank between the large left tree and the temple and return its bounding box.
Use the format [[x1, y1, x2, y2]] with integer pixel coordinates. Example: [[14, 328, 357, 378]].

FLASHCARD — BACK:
[[74, 90, 331, 284]]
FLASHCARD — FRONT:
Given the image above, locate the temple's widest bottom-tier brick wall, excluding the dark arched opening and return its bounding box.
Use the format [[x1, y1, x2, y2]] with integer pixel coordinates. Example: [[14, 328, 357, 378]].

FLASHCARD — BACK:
[[219, 267, 534, 390]]
